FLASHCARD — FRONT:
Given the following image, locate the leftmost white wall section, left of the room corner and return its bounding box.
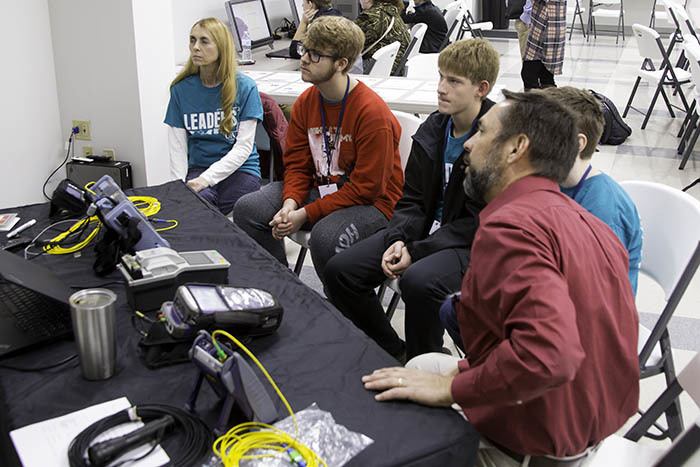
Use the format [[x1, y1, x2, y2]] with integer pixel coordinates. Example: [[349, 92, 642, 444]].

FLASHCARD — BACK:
[[0, 0, 63, 209]]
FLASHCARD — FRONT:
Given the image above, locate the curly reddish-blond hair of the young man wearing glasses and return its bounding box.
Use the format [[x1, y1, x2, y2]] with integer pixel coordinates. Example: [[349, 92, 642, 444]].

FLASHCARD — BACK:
[[303, 16, 365, 73]]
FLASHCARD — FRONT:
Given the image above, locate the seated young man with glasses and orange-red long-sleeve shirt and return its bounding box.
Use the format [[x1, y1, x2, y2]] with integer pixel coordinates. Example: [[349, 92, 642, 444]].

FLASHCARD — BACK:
[[233, 16, 403, 278]]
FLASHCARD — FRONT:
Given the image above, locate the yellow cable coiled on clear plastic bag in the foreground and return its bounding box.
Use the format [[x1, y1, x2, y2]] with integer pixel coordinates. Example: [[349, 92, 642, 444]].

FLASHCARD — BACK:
[[211, 329, 326, 467]]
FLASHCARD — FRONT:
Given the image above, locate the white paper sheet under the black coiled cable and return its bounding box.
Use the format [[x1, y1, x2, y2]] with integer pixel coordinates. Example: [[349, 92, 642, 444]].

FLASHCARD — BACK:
[[10, 397, 170, 467]]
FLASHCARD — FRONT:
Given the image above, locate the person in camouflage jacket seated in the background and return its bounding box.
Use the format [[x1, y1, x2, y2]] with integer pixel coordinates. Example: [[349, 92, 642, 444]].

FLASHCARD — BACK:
[[355, 0, 411, 73]]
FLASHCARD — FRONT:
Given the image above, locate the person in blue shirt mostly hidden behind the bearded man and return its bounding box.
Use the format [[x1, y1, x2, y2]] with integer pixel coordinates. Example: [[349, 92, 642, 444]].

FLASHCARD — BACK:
[[440, 86, 642, 350]]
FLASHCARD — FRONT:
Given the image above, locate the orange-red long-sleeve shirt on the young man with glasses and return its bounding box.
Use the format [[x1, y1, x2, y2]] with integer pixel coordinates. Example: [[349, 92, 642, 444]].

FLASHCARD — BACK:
[[282, 82, 403, 222]]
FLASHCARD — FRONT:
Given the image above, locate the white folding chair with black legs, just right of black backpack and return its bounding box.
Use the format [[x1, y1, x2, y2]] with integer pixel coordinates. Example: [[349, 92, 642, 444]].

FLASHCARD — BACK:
[[622, 24, 690, 129]]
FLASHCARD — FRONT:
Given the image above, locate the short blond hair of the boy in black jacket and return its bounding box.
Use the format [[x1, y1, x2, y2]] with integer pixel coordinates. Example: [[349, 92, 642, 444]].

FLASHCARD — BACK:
[[438, 39, 499, 96]]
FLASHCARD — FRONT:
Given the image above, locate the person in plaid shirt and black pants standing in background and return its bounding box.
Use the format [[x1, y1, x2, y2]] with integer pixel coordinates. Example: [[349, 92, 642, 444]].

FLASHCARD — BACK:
[[520, 0, 566, 91]]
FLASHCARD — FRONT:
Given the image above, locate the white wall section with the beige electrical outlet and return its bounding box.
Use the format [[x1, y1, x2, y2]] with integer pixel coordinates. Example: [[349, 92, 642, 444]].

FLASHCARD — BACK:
[[48, 0, 146, 186]]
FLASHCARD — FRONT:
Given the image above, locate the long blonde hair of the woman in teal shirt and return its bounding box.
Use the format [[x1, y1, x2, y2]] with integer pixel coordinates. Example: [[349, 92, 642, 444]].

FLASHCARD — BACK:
[[170, 18, 236, 136]]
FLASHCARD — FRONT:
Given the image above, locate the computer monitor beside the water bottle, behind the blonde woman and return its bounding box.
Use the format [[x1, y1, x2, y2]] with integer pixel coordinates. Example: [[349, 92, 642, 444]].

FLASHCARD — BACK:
[[224, 0, 275, 52]]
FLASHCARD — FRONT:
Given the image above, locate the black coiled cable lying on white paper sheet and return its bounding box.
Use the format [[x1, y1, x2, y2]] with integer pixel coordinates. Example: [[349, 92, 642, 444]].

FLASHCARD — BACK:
[[68, 404, 214, 467]]
